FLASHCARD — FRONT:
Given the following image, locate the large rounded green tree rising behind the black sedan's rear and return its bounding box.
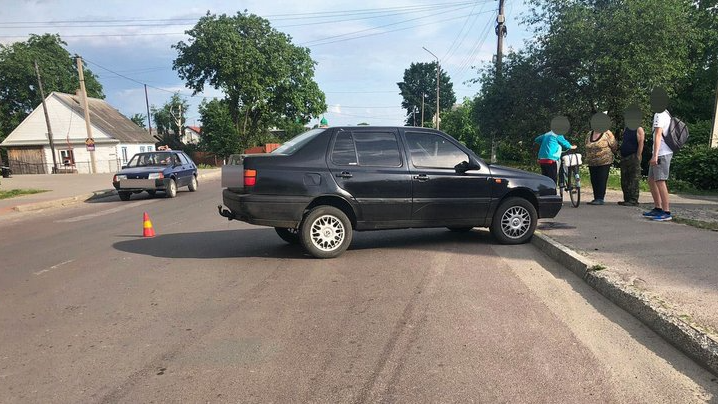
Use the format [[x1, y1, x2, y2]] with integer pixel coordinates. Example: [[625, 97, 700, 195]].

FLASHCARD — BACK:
[[173, 12, 326, 146]]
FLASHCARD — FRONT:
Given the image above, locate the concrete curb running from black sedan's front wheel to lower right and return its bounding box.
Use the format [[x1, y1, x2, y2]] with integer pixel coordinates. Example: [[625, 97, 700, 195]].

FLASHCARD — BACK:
[[531, 232, 718, 375]]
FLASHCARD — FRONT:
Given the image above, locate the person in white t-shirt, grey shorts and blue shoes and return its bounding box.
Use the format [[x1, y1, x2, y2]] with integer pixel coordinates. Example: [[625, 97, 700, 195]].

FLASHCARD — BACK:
[[643, 87, 673, 222]]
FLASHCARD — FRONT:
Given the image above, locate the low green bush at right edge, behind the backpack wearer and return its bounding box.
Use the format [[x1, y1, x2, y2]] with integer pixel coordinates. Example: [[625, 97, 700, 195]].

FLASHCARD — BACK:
[[671, 146, 718, 189]]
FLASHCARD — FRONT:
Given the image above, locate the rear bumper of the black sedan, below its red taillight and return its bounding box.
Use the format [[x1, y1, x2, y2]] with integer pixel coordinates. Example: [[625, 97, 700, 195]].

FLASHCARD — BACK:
[[220, 189, 312, 228]]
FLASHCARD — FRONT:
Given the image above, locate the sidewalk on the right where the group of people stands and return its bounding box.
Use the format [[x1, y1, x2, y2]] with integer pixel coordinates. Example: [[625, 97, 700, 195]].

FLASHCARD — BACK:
[[534, 189, 718, 373]]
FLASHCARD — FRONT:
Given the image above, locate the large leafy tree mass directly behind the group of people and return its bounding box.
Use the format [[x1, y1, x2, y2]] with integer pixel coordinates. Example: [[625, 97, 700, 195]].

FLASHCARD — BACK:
[[474, 0, 704, 163]]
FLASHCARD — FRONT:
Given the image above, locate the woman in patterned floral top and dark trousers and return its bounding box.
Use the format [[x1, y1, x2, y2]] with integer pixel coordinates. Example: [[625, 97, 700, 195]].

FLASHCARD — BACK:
[[584, 112, 618, 205]]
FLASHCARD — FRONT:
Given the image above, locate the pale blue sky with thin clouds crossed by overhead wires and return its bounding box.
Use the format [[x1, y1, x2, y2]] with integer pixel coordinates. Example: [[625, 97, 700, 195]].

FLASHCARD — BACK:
[[0, 0, 530, 126]]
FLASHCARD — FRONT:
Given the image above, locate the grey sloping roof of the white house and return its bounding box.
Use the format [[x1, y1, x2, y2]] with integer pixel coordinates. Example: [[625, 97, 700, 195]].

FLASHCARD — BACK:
[[53, 92, 157, 143]]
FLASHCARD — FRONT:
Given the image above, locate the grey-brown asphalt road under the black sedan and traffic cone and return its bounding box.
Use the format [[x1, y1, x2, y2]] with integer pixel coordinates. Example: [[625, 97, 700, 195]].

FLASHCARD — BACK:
[[0, 180, 718, 403]]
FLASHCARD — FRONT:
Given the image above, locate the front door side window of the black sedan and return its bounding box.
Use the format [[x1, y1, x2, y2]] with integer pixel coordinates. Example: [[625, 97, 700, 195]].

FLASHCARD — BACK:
[[406, 132, 469, 168]]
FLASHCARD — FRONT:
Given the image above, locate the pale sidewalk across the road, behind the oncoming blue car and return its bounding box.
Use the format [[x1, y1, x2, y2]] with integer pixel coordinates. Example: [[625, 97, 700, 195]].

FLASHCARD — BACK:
[[0, 168, 220, 217]]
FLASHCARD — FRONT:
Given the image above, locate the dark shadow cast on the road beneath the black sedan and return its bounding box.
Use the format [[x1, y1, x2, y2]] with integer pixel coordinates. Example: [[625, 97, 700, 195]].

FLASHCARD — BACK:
[[112, 228, 495, 259]]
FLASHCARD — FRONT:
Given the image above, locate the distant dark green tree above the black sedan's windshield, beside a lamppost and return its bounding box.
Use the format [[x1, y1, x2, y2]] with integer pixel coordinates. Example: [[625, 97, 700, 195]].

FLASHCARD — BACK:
[[396, 62, 456, 126]]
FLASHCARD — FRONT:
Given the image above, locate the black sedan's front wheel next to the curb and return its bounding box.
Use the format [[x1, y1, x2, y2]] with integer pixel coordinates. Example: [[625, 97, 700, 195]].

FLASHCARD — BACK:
[[491, 197, 538, 244]]
